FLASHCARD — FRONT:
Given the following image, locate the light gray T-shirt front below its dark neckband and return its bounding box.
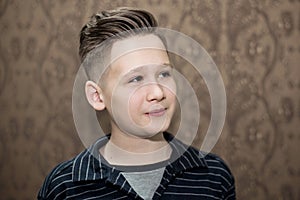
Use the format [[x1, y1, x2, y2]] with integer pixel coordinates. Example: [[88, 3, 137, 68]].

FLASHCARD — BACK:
[[122, 167, 165, 200]]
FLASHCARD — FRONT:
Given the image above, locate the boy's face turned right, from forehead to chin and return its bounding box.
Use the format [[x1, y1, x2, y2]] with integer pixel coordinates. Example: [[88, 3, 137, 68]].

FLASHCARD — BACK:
[[101, 35, 176, 138]]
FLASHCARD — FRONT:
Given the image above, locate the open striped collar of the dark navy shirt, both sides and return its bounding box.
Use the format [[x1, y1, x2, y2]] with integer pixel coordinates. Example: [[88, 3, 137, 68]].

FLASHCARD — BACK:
[[72, 133, 207, 181]]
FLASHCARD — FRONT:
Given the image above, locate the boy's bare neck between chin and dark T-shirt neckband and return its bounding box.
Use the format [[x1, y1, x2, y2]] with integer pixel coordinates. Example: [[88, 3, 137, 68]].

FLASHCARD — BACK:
[[100, 126, 172, 166]]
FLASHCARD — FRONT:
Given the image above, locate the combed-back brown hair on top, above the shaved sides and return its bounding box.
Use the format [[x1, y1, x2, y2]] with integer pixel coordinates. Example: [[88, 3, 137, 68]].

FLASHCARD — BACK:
[[79, 8, 157, 62]]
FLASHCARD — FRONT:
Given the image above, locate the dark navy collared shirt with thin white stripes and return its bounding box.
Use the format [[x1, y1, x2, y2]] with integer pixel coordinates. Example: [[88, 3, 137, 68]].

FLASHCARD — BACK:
[[38, 133, 235, 200]]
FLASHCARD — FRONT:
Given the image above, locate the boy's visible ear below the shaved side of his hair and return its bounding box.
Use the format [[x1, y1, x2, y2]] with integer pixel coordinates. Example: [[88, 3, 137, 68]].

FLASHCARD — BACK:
[[85, 81, 105, 110]]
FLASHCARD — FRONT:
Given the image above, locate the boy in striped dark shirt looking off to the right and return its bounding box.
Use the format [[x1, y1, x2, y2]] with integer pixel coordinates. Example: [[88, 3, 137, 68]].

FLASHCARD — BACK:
[[38, 8, 235, 199]]
